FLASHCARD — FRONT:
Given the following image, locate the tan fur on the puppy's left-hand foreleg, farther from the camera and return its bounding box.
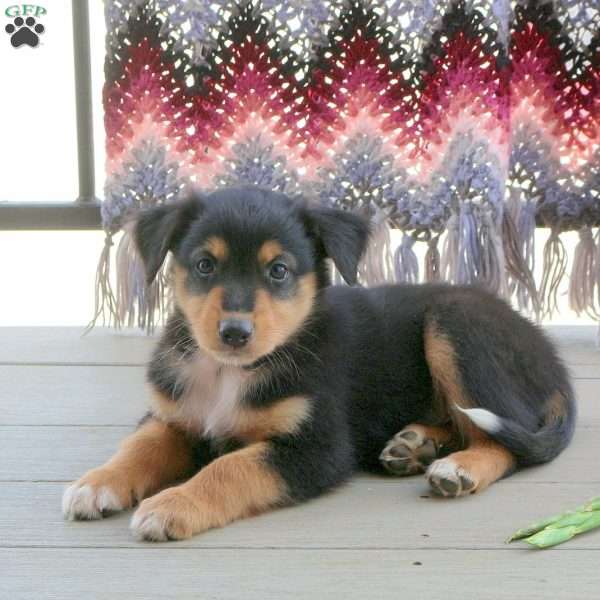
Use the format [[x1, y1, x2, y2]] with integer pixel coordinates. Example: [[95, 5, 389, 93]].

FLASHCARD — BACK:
[[69, 420, 194, 508]]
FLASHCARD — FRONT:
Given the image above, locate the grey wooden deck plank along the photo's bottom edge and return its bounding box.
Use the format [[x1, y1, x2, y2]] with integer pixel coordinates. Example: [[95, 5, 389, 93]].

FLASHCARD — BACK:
[[0, 549, 600, 600]]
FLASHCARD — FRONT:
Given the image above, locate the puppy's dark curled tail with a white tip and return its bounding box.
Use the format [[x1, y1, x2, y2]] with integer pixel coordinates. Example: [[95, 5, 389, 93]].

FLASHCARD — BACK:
[[456, 394, 577, 467]]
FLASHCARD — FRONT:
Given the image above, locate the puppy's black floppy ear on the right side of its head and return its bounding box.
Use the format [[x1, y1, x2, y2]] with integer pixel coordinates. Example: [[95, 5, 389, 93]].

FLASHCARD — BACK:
[[306, 207, 370, 285]]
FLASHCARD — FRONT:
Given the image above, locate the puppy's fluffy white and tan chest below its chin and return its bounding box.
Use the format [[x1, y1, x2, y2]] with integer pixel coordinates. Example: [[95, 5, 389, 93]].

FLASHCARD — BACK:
[[158, 356, 253, 438]]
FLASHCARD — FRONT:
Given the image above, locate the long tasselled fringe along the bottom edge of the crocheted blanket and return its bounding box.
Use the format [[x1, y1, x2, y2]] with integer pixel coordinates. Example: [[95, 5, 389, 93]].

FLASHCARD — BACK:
[[86, 216, 600, 333]]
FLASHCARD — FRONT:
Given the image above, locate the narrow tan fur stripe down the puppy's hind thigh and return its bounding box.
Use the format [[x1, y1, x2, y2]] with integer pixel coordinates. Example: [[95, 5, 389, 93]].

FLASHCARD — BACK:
[[425, 323, 476, 438]]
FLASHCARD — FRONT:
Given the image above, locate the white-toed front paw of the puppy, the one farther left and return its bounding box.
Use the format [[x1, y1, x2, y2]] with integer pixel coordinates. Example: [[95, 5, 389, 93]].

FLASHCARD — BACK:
[[62, 468, 131, 521]]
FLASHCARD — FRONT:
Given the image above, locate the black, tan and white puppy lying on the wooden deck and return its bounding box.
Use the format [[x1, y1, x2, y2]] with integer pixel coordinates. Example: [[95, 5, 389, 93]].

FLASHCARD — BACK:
[[63, 187, 575, 540]]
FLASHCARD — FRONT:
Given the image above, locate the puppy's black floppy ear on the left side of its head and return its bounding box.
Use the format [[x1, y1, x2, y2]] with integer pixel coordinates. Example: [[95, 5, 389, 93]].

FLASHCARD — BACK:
[[133, 198, 201, 285]]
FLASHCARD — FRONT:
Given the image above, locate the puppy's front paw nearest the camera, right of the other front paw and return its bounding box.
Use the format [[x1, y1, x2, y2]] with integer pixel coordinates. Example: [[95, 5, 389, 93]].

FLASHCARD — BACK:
[[131, 488, 207, 542]]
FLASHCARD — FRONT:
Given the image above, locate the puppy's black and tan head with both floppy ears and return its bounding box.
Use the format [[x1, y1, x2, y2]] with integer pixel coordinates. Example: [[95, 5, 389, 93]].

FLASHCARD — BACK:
[[135, 187, 368, 365]]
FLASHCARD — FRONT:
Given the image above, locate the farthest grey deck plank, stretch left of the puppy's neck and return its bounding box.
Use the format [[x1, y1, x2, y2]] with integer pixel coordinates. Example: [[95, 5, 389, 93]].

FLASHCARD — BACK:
[[0, 327, 156, 365]]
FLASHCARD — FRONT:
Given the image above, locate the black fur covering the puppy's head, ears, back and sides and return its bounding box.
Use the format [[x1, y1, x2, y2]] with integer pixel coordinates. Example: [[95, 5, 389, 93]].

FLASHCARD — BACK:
[[136, 187, 575, 502]]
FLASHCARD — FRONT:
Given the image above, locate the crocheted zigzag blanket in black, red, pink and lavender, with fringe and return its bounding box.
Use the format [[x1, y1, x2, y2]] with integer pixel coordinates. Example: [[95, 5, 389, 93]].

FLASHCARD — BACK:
[[96, 0, 600, 328]]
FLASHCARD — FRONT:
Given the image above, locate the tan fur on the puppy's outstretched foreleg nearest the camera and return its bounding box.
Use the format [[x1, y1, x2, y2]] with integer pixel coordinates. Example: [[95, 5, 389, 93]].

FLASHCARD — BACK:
[[134, 443, 286, 539]]
